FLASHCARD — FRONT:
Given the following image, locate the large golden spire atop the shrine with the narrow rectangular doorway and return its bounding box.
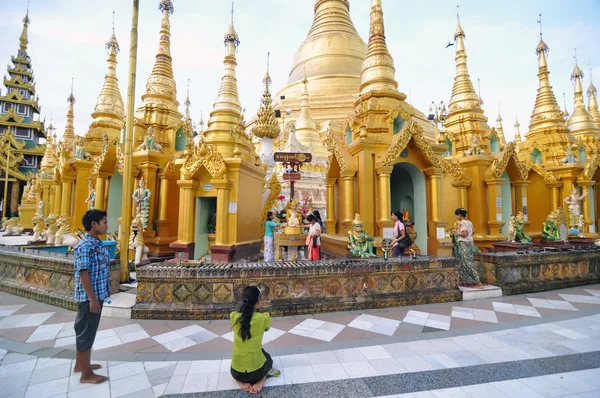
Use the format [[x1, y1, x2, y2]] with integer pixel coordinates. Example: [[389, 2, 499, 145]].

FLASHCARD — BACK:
[[204, 1, 243, 149]]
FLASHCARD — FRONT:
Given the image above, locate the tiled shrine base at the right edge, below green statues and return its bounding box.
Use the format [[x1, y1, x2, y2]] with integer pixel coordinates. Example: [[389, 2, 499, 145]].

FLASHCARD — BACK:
[[475, 247, 600, 295]]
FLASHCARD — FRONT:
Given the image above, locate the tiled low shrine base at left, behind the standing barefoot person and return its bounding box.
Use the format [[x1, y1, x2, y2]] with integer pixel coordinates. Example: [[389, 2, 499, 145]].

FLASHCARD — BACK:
[[0, 245, 119, 310]]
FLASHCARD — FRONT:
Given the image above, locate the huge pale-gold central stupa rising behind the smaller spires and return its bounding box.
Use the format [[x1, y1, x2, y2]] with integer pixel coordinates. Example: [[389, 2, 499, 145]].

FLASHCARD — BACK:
[[275, 0, 367, 124]]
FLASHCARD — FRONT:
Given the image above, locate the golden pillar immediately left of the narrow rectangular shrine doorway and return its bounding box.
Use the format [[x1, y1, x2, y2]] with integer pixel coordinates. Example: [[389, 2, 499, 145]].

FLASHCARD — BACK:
[[171, 180, 200, 260]]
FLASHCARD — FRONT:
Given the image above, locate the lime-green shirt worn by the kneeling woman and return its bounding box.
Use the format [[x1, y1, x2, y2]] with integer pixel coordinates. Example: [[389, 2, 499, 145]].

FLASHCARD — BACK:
[[229, 311, 271, 373]]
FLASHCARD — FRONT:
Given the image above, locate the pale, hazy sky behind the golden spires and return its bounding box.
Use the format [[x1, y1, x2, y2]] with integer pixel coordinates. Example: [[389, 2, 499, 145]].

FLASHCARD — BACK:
[[0, 0, 600, 140]]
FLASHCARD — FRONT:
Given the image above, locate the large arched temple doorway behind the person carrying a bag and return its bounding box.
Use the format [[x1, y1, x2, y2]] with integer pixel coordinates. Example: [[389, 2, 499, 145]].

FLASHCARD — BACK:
[[390, 162, 427, 255]]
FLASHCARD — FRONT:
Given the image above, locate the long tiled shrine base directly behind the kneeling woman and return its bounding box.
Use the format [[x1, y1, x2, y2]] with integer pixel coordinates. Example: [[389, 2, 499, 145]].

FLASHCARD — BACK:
[[132, 257, 461, 319]]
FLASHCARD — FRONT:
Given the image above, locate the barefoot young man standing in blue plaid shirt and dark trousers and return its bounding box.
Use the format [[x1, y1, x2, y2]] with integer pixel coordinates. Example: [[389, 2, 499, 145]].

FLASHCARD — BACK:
[[73, 210, 110, 384]]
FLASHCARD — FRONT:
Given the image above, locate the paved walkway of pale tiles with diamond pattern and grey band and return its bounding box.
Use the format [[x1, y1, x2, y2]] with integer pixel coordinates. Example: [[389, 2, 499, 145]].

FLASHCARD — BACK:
[[0, 285, 600, 398]]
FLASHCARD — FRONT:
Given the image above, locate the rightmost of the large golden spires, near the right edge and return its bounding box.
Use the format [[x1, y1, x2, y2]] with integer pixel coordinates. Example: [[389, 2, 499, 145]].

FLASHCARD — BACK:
[[527, 14, 565, 137]]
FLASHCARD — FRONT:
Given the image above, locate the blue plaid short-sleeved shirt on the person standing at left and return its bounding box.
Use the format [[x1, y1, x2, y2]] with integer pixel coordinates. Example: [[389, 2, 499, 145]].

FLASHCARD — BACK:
[[75, 234, 110, 303]]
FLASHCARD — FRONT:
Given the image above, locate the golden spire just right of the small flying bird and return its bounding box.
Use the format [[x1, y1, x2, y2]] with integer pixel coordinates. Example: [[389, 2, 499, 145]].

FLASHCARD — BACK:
[[448, 7, 483, 116]]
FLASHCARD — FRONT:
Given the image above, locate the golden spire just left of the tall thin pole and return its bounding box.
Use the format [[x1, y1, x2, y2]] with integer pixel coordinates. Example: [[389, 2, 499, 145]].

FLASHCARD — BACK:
[[90, 17, 125, 134]]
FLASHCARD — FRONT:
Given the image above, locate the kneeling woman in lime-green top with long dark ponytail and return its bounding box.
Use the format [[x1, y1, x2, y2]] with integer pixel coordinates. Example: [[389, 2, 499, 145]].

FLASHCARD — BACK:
[[229, 286, 281, 394]]
